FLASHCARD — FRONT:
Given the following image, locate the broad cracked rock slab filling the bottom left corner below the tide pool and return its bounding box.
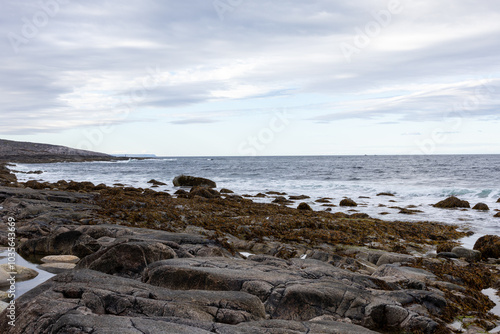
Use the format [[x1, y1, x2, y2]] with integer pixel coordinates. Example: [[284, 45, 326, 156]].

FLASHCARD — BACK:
[[0, 270, 265, 334]]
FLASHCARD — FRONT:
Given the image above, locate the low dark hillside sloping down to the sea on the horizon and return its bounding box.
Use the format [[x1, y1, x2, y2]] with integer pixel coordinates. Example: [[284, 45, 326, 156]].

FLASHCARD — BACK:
[[0, 139, 114, 162]]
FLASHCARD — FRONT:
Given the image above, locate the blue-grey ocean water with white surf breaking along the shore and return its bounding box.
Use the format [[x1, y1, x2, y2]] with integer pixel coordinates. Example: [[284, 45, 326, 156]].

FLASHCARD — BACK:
[[12, 155, 500, 247]]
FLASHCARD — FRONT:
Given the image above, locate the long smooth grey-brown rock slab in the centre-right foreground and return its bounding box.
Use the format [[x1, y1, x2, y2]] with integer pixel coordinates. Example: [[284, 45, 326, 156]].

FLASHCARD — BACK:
[[143, 255, 435, 333]]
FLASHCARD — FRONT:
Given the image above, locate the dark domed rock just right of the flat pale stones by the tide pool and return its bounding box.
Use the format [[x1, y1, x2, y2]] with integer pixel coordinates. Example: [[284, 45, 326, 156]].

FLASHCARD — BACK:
[[77, 242, 176, 278]]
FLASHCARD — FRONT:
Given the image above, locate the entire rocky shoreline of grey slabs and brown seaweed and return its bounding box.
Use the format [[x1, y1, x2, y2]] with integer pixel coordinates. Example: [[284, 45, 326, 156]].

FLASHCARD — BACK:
[[0, 166, 500, 334]]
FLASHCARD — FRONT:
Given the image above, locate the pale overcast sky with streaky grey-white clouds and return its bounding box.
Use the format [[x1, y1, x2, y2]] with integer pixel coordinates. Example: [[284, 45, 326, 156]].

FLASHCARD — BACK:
[[0, 0, 500, 156]]
